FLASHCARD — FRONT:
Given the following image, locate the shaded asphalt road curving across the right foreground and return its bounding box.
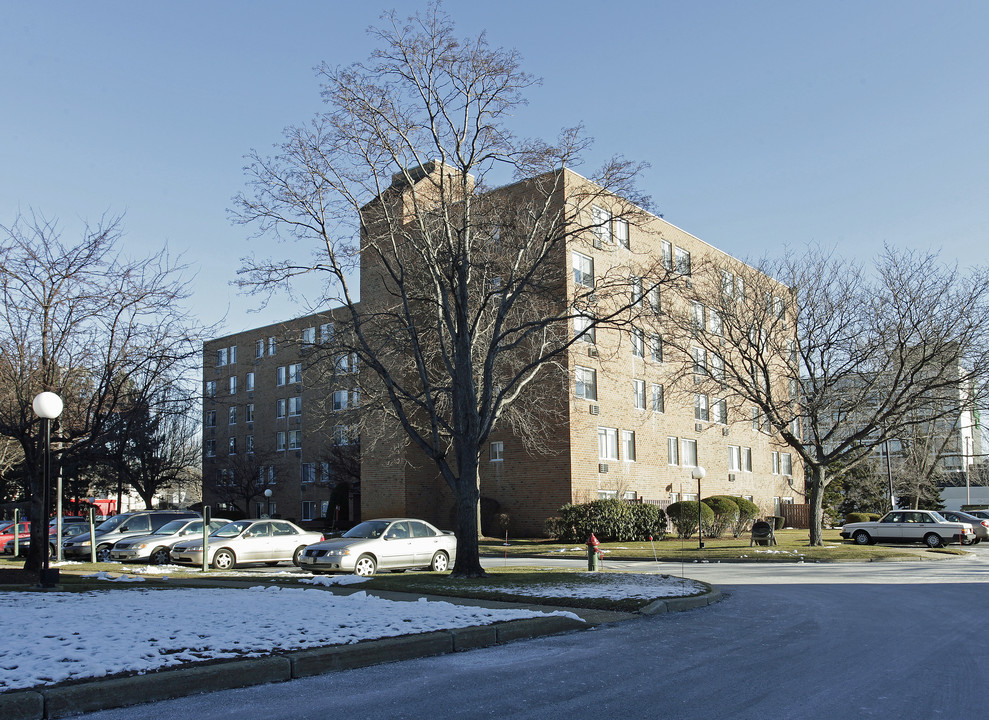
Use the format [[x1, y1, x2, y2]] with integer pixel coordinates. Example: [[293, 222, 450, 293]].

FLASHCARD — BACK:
[[73, 548, 989, 720]]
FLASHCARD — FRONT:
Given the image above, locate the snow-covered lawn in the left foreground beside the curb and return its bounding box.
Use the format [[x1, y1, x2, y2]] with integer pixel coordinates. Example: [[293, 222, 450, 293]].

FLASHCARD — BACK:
[[0, 584, 576, 691]]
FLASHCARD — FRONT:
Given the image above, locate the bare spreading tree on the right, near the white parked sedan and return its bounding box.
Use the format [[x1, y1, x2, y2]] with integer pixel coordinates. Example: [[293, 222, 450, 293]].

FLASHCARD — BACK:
[[668, 249, 989, 545]]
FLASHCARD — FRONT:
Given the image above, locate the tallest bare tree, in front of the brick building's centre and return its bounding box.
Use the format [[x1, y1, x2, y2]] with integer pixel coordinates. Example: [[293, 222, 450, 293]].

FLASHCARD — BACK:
[[235, 5, 668, 577]]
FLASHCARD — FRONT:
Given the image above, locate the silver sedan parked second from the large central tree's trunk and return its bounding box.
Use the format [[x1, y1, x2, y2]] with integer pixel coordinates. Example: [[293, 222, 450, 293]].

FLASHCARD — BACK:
[[171, 520, 323, 570]]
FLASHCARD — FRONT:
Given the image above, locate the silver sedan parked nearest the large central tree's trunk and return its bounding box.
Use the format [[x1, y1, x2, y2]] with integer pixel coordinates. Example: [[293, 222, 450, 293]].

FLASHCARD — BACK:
[[300, 518, 457, 577]]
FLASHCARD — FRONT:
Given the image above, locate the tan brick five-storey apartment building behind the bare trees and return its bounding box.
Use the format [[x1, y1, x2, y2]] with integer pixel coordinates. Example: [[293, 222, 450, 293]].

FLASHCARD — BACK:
[[203, 163, 804, 535]]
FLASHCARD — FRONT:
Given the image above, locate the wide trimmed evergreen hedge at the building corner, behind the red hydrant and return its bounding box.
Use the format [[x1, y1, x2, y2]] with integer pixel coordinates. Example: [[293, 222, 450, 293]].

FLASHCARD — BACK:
[[546, 500, 666, 543]]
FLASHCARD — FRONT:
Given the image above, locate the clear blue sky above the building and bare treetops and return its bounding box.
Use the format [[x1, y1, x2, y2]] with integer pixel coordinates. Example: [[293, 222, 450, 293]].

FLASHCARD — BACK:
[[0, 0, 989, 332]]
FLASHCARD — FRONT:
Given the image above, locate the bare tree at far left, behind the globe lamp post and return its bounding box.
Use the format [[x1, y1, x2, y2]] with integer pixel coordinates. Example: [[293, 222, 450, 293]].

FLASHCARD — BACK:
[[0, 211, 204, 569]]
